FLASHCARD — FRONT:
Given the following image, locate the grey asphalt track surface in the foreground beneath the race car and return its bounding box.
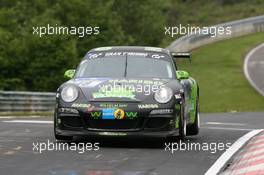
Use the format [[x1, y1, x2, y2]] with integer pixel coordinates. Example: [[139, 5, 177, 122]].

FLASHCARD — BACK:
[[0, 113, 264, 175]]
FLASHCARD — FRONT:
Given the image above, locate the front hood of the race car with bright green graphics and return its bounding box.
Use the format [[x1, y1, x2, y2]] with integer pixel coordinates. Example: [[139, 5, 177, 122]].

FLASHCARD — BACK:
[[66, 78, 181, 102]]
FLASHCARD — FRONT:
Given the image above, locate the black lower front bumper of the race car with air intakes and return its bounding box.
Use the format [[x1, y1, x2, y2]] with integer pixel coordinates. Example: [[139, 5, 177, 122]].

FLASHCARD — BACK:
[[55, 103, 179, 137]]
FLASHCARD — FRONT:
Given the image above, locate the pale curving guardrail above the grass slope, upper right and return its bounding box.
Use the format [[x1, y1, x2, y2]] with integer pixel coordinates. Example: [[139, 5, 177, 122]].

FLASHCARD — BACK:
[[167, 15, 264, 52]]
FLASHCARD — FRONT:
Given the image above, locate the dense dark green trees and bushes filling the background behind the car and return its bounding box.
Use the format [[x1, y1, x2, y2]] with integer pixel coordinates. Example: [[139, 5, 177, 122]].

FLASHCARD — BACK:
[[0, 0, 263, 91]]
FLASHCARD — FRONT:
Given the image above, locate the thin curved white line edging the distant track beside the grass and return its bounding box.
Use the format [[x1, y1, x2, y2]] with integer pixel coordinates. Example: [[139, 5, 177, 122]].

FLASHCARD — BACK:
[[244, 43, 264, 96]]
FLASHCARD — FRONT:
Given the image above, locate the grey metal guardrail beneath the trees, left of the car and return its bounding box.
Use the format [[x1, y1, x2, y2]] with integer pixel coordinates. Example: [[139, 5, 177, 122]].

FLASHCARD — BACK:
[[0, 91, 55, 112]]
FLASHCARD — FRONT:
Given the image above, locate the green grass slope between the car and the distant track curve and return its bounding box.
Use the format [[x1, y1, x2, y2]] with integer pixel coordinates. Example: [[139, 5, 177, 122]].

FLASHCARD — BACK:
[[178, 33, 264, 112]]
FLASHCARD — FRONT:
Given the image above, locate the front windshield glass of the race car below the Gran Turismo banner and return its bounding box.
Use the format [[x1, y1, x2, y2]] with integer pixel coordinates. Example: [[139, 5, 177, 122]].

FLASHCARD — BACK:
[[76, 56, 174, 78]]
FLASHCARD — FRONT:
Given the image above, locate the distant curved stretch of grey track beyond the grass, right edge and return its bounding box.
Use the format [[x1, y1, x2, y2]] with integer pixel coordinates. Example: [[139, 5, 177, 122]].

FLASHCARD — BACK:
[[244, 43, 264, 96]]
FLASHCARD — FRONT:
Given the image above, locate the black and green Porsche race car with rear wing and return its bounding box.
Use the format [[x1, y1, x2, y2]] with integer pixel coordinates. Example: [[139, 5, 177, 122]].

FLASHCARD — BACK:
[[54, 46, 200, 140]]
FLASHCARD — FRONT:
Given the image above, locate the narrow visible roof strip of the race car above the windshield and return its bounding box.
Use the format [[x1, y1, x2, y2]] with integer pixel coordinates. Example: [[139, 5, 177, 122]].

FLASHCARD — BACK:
[[89, 46, 169, 54]]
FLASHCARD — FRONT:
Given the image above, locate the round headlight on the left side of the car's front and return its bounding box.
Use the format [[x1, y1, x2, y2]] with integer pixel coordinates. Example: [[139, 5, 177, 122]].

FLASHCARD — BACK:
[[61, 85, 78, 102]]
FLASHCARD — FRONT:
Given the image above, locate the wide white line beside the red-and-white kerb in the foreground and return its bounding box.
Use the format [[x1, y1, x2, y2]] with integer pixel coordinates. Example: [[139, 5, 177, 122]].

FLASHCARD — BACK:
[[205, 129, 263, 175]]
